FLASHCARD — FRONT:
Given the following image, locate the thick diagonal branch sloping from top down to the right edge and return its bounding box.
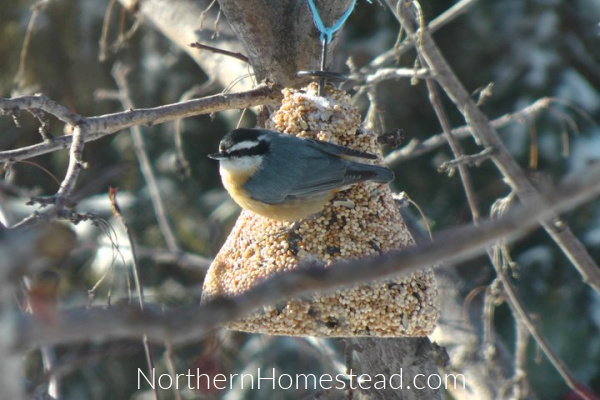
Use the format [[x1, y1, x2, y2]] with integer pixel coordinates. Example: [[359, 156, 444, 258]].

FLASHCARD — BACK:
[[388, 0, 600, 293]]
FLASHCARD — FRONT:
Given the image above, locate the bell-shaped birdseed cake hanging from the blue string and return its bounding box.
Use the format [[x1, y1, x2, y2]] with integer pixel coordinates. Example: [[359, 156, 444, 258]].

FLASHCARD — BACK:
[[203, 83, 439, 337]]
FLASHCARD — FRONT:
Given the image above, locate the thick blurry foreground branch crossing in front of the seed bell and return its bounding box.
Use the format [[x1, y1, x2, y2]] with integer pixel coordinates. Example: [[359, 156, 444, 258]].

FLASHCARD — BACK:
[[15, 161, 600, 350]]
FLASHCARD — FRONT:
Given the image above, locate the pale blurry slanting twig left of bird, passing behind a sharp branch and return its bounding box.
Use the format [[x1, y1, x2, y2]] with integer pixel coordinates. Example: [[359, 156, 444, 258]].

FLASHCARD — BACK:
[[112, 63, 180, 253]]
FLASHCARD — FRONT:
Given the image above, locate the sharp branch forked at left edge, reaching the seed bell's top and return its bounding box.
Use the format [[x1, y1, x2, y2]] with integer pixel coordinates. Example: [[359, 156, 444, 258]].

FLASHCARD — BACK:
[[0, 85, 281, 162]]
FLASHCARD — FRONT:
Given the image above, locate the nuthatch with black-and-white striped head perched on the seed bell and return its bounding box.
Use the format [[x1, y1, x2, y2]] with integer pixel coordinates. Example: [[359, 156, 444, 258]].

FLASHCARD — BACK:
[[208, 128, 394, 221]]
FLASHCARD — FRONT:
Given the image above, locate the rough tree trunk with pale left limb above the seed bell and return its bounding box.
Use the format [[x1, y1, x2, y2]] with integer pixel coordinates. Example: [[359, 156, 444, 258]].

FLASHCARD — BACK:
[[120, 0, 352, 89]]
